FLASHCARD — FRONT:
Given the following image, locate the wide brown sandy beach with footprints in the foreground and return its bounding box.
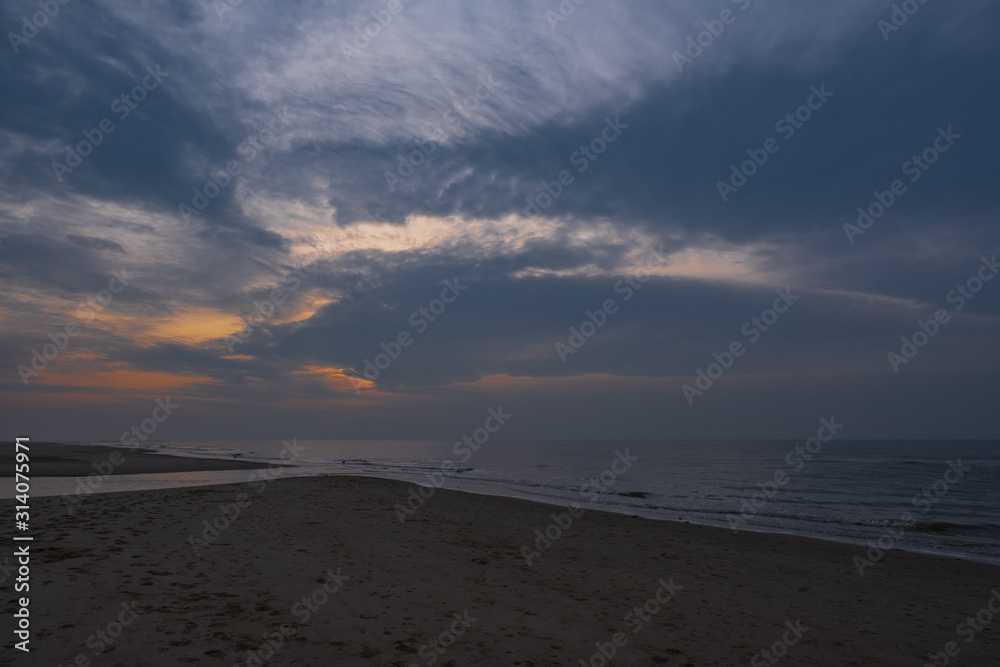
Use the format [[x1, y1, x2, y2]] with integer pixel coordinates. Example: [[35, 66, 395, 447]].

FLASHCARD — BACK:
[[13, 477, 1000, 667]]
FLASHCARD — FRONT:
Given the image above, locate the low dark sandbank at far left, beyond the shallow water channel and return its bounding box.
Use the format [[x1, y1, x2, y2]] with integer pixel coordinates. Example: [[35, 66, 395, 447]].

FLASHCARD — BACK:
[[0, 442, 282, 477]]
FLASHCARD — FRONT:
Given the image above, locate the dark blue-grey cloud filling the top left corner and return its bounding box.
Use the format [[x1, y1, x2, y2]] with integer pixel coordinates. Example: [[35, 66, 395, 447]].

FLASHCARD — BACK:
[[0, 3, 290, 247]]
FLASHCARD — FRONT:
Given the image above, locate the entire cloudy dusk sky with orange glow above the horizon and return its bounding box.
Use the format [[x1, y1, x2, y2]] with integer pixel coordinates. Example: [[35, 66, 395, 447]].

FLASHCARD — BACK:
[[0, 0, 1000, 441]]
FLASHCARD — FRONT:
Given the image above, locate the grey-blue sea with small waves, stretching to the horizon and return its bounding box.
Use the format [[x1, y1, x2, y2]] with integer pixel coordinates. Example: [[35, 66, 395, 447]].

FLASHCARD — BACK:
[[15, 439, 1000, 564]]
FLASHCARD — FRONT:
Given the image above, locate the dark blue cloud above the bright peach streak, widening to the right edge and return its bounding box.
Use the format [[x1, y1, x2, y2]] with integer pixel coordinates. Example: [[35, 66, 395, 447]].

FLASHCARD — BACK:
[[197, 4, 1000, 245]]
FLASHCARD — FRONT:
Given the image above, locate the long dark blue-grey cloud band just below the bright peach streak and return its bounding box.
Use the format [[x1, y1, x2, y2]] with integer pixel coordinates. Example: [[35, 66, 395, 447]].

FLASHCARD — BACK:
[[164, 237, 998, 389]]
